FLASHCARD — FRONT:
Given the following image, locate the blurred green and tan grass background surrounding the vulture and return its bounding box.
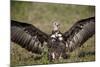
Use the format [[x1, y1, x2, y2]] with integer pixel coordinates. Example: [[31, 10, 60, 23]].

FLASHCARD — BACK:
[[11, 1, 95, 66]]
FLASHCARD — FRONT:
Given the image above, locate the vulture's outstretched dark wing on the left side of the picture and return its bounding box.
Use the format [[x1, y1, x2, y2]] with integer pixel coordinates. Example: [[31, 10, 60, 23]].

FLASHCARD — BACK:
[[11, 20, 48, 54]]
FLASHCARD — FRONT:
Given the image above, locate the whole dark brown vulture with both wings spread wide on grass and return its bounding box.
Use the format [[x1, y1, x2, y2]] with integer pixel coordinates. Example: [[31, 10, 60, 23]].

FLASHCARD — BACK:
[[11, 17, 95, 61]]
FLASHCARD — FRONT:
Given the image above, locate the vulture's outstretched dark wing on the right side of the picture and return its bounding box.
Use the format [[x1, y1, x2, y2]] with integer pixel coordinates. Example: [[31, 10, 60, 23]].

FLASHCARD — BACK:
[[63, 17, 95, 51]]
